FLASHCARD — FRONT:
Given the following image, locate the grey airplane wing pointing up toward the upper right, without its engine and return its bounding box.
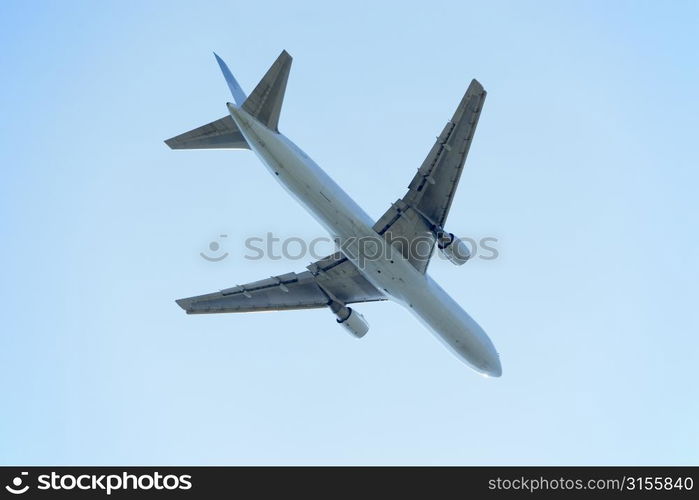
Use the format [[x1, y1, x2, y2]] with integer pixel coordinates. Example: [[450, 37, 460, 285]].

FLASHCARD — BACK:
[[374, 80, 486, 273]]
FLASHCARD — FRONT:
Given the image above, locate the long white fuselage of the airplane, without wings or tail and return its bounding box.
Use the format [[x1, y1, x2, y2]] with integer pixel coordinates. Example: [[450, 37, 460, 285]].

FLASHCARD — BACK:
[[228, 104, 502, 377]]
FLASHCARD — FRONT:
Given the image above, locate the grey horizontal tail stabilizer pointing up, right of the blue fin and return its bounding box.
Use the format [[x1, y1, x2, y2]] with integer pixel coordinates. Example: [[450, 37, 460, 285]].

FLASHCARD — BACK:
[[243, 50, 291, 132]]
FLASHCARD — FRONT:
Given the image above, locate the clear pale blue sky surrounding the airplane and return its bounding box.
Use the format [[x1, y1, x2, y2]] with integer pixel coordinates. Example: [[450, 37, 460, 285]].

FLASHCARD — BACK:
[[0, 1, 699, 464]]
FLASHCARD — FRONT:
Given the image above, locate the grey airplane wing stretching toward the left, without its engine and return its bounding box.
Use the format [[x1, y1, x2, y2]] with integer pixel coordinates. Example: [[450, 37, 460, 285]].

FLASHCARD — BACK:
[[177, 252, 386, 314]]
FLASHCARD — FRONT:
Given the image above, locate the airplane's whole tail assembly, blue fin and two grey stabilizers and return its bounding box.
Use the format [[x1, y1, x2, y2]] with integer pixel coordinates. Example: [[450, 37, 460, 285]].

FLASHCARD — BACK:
[[165, 50, 292, 149]]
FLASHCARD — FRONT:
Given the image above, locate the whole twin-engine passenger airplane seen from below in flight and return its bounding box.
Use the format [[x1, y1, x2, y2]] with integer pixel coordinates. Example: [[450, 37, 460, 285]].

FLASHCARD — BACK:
[[165, 51, 502, 377]]
